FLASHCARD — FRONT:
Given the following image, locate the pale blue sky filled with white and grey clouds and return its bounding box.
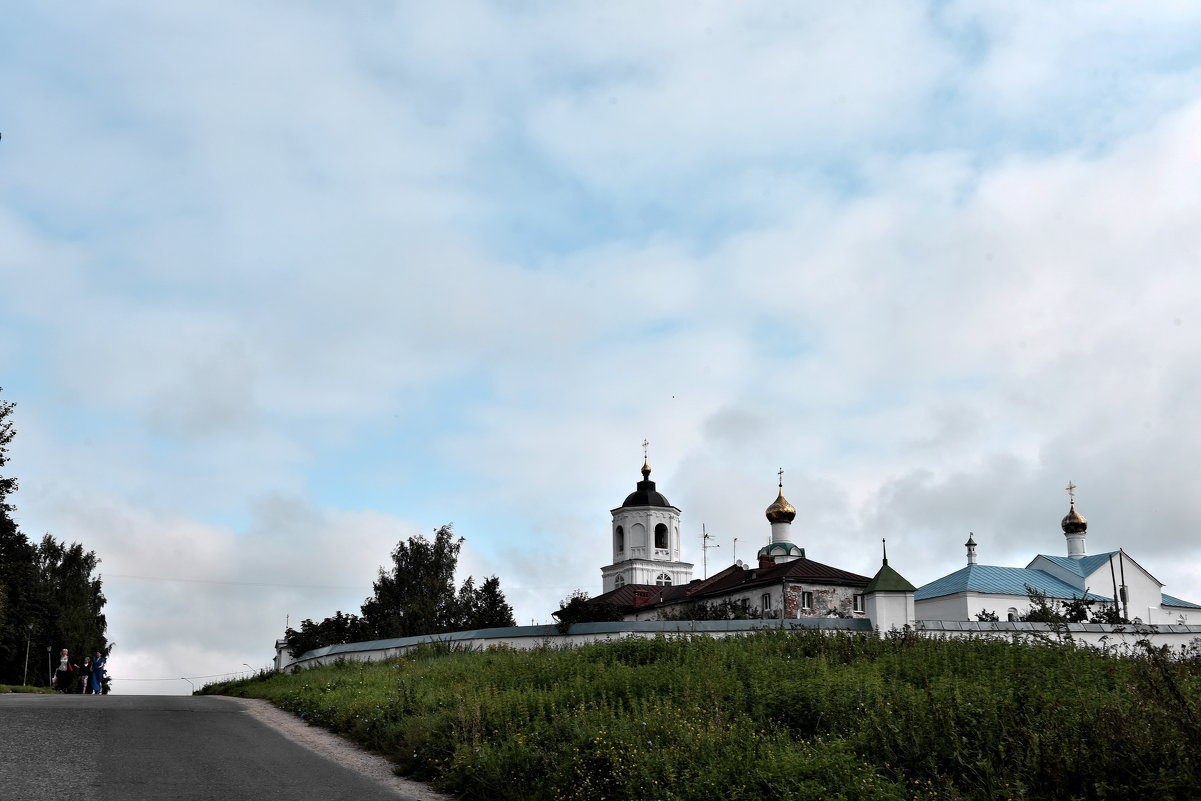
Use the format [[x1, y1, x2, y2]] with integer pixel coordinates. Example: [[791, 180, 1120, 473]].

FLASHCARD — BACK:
[[0, 0, 1201, 693]]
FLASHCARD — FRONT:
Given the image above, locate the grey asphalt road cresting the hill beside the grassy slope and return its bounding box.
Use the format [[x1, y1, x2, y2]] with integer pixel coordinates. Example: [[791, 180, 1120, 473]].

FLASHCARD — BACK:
[[0, 693, 427, 801]]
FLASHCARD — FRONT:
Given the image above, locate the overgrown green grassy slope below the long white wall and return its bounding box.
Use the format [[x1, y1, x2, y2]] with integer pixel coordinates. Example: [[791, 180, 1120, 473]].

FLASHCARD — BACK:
[[203, 632, 1201, 801]]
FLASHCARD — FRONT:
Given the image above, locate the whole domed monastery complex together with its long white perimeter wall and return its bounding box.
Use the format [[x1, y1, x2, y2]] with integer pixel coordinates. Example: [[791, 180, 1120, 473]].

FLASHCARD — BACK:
[[275, 459, 1201, 669]]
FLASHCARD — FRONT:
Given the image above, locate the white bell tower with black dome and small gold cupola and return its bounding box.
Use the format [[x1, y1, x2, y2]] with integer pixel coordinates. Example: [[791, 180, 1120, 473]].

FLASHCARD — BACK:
[[601, 449, 692, 592]]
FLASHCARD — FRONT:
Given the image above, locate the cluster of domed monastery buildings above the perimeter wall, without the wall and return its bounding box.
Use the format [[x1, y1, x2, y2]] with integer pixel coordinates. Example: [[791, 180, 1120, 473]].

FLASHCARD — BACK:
[[594, 459, 1201, 626]]
